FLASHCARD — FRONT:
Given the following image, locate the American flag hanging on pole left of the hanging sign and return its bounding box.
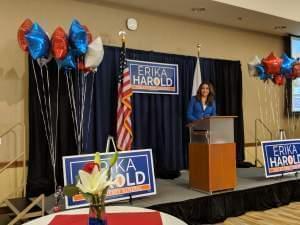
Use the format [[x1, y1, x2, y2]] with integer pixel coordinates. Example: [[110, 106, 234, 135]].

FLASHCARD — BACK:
[[117, 41, 133, 150]]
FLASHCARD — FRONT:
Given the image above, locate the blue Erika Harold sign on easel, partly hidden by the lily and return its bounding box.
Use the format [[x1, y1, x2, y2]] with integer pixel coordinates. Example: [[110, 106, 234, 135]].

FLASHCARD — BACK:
[[63, 149, 156, 209]]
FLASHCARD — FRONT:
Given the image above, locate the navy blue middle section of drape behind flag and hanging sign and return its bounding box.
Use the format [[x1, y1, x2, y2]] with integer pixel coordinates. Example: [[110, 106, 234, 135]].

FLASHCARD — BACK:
[[86, 47, 195, 170]]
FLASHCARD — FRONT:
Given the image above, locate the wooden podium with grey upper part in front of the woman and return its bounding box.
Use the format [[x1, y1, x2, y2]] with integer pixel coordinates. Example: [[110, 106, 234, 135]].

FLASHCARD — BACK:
[[188, 116, 236, 193]]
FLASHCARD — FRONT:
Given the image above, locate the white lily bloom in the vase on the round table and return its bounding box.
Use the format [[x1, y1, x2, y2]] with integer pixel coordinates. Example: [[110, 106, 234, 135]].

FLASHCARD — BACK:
[[76, 166, 112, 195]]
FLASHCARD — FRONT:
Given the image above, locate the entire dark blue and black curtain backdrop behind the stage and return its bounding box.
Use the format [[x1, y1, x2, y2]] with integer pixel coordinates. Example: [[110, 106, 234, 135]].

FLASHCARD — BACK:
[[28, 47, 244, 196]]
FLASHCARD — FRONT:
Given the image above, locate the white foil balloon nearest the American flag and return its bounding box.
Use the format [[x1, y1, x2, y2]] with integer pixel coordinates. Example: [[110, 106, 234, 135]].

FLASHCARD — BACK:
[[85, 37, 104, 69]]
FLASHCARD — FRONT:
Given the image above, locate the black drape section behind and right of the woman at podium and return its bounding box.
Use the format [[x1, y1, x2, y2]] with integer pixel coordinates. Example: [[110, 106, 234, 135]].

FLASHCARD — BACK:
[[201, 58, 245, 163]]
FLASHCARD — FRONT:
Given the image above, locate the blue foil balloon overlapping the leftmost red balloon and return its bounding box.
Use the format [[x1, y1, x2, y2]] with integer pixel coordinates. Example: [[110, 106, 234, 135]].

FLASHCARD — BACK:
[[25, 23, 50, 59]]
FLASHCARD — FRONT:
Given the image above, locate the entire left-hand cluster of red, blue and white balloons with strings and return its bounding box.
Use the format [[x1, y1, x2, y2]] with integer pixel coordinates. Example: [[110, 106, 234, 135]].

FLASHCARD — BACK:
[[17, 19, 104, 210]]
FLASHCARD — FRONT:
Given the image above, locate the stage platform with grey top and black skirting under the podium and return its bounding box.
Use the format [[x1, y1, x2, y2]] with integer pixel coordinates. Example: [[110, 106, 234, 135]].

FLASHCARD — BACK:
[[46, 168, 300, 225]]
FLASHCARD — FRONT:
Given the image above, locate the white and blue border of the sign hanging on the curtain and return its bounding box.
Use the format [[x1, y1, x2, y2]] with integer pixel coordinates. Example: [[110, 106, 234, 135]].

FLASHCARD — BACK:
[[126, 59, 179, 95]]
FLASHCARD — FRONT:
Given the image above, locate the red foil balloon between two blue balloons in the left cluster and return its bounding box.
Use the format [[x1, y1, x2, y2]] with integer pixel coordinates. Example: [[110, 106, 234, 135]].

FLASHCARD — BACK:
[[51, 27, 68, 59]]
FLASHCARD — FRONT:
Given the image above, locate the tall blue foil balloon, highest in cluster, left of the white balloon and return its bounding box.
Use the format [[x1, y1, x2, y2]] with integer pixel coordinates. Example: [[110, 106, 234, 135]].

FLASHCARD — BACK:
[[69, 20, 88, 55]]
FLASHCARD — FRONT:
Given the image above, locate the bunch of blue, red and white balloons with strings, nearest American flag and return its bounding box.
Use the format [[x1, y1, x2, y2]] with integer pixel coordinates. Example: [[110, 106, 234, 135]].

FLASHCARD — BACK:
[[58, 20, 104, 154]]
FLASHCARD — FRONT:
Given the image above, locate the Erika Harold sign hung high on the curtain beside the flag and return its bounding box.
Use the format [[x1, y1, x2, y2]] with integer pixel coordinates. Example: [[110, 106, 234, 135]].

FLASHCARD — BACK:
[[127, 59, 178, 95]]
